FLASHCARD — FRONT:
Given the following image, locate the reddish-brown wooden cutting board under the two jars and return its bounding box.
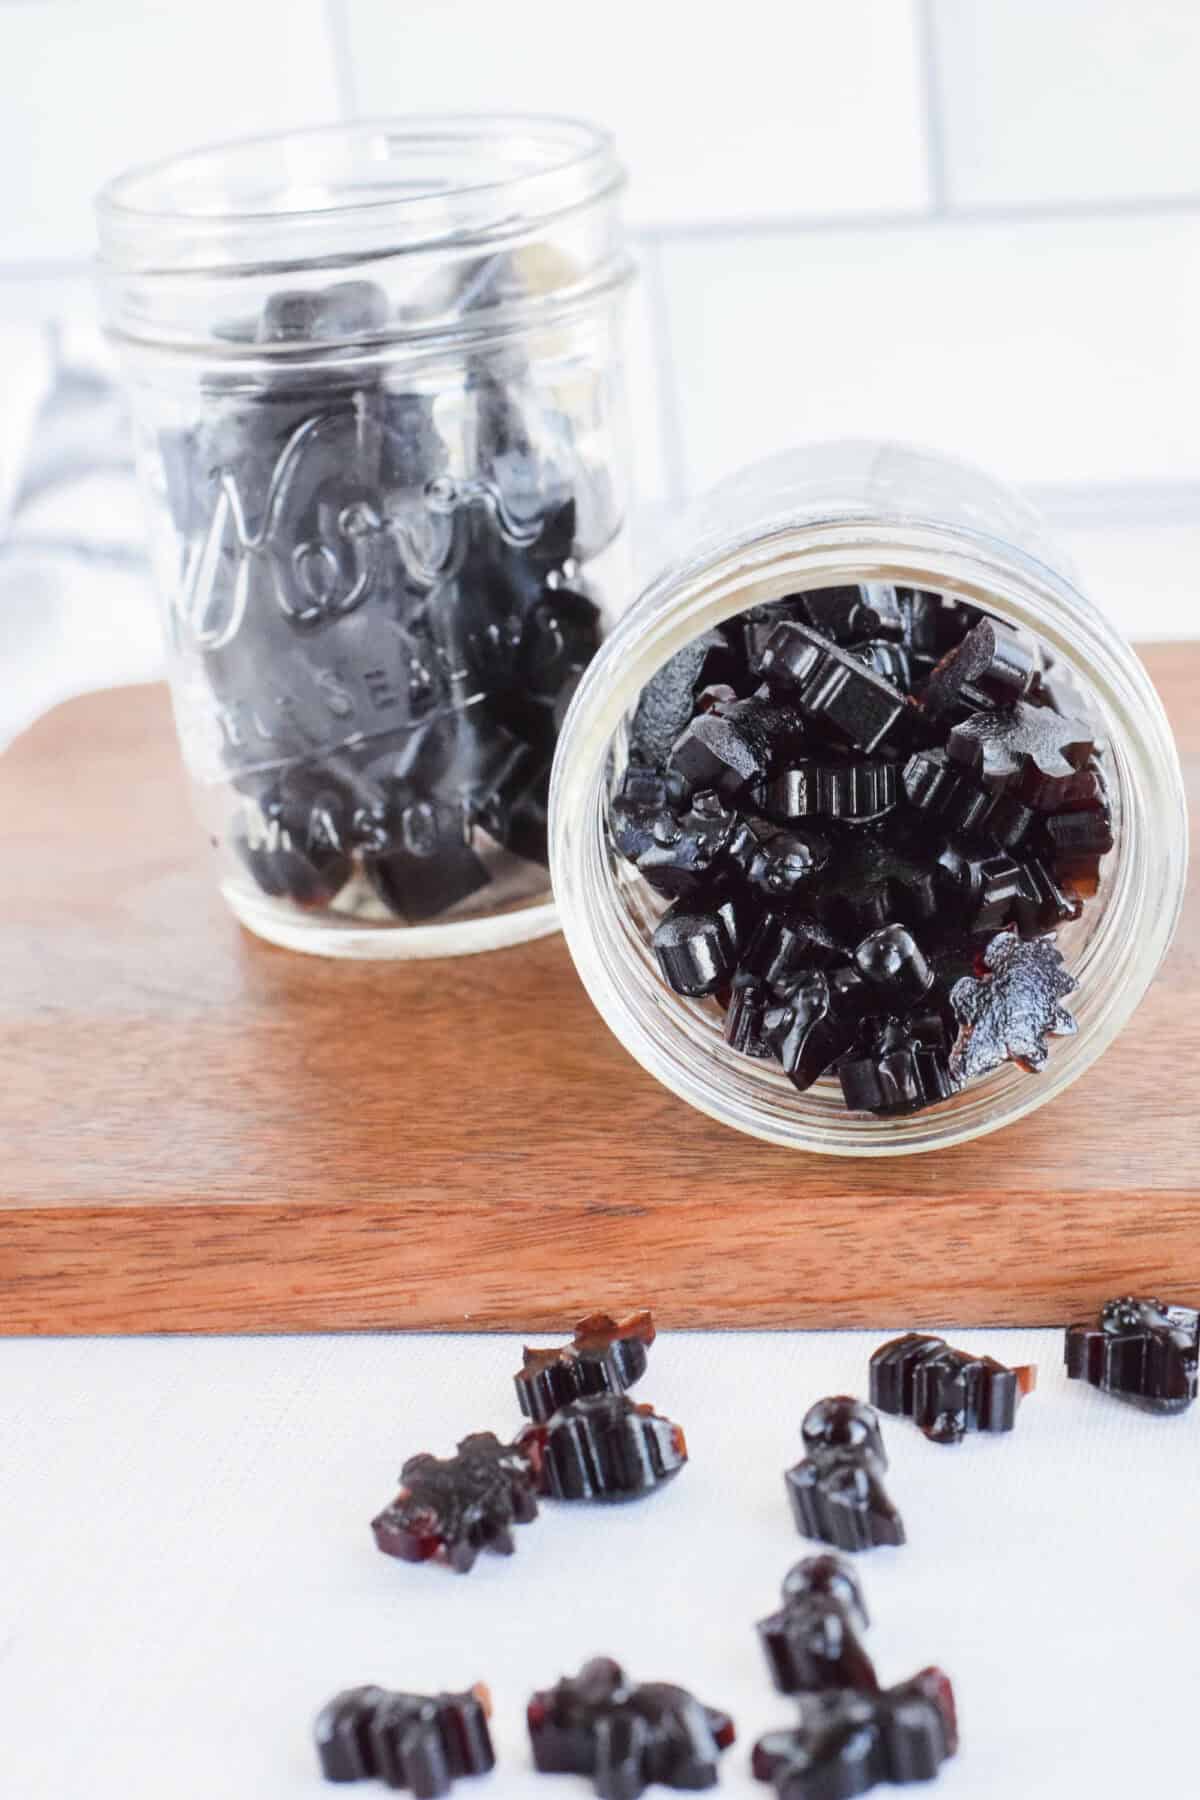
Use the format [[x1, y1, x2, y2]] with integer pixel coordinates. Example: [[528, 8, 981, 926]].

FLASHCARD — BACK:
[[0, 644, 1200, 1334]]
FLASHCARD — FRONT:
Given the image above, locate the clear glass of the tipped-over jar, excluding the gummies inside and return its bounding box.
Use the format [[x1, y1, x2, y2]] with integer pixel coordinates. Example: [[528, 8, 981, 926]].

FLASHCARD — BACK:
[[551, 441, 1187, 1156]]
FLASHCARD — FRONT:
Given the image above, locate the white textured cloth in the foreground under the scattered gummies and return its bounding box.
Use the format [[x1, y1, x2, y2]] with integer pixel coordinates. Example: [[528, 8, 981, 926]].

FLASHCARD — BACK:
[[0, 1332, 1200, 1800]]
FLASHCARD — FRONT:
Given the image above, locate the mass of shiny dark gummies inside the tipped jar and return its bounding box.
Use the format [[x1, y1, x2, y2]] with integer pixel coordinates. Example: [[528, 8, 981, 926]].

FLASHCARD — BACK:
[[608, 581, 1114, 1118]]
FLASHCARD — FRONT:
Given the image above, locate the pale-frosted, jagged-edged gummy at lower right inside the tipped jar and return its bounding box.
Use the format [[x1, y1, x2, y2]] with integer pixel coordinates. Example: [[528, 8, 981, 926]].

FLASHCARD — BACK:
[[950, 931, 1076, 1085]]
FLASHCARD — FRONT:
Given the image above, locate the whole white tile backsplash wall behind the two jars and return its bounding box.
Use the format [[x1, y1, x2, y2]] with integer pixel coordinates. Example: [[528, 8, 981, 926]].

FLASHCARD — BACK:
[[0, 0, 1200, 635]]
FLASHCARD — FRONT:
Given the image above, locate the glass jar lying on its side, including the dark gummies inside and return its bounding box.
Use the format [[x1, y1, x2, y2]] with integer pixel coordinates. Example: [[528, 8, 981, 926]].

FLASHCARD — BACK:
[[551, 441, 1187, 1156]]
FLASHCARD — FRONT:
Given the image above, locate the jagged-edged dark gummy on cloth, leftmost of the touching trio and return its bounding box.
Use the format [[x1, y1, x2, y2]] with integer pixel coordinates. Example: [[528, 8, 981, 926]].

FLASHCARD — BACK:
[[371, 1431, 538, 1575]]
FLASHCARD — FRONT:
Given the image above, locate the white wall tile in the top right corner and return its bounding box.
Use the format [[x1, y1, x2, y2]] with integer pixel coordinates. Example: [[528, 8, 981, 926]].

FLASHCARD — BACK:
[[932, 0, 1200, 207]]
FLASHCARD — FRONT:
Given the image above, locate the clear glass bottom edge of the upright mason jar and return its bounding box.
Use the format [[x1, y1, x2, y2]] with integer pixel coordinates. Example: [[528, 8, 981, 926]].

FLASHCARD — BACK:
[[221, 882, 560, 963]]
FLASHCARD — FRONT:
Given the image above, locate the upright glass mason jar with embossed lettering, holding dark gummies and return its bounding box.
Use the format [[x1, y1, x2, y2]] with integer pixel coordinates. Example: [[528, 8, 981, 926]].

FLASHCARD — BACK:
[[97, 117, 631, 956]]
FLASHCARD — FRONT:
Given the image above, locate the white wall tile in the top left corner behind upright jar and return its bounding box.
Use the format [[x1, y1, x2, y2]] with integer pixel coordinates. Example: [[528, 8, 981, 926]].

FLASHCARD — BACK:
[[0, 0, 338, 263]]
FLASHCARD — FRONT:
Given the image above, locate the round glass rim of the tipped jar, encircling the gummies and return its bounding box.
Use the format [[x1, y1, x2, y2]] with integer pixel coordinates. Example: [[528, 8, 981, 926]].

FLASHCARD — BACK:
[[551, 518, 1186, 1156]]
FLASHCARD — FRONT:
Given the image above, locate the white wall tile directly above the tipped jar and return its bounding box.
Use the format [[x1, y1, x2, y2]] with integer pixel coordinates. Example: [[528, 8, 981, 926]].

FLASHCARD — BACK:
[[662, 214, 1200, 493]]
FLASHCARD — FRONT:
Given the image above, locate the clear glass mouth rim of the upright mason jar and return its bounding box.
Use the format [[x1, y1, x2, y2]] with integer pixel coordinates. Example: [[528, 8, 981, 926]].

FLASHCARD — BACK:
[[95, 113, 622, 272]]
